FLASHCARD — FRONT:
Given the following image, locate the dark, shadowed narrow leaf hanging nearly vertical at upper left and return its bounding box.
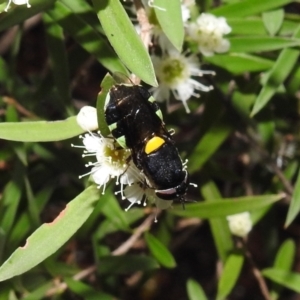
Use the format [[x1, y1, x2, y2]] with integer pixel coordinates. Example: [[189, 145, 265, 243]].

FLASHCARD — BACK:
[[43, 14, 71, 103]]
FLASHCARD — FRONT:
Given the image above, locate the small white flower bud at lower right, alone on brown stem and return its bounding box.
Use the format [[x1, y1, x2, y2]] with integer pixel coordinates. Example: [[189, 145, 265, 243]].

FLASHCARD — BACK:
[[227, 212, 252, 237]]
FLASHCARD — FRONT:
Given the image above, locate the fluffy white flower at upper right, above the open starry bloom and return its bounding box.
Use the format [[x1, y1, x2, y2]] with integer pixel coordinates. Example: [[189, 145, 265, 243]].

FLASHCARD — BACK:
[[187, 13, 231, 56]]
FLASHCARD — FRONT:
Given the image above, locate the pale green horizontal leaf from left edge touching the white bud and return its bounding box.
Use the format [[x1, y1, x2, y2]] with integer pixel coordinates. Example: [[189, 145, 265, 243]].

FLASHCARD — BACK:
[[0, 116, 84, 142]]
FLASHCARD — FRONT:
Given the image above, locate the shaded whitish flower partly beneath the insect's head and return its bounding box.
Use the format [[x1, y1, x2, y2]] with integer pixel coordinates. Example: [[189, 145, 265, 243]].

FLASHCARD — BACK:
[[124, 182, 173, 211]]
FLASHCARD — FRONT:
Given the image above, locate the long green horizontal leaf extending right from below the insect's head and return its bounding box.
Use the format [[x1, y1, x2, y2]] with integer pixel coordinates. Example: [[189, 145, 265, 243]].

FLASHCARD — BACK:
[[169, 194, 285, 218]]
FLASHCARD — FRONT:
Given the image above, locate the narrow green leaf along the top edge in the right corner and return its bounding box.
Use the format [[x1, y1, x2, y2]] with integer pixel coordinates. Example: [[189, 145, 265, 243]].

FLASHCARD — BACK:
[[209, 0, 294, 18]]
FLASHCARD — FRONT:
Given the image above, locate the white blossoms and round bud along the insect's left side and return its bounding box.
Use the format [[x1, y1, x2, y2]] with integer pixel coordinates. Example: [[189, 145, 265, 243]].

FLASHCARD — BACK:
[[72, 106, 172, 210]]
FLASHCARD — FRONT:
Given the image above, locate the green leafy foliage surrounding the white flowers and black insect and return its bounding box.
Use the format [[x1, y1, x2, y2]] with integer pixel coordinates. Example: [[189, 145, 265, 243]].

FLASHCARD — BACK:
[[0, 0, 300, 300]]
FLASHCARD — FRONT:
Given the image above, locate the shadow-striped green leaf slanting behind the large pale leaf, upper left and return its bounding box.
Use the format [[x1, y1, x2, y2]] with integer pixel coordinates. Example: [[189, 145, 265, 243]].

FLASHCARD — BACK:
[[47, 1, 127, 74]]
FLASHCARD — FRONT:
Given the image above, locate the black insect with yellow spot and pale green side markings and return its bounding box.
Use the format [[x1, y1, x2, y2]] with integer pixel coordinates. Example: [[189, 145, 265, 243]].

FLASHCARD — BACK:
[[105, 78, 193, 207]]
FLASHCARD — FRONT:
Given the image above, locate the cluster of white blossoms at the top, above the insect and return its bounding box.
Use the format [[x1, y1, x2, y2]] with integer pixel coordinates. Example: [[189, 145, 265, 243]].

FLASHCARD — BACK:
[[145, 0, 231, 113]]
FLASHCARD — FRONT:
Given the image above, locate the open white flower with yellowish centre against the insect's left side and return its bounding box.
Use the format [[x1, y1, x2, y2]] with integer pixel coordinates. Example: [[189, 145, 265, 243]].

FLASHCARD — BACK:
[[72, 133, 134, 194]]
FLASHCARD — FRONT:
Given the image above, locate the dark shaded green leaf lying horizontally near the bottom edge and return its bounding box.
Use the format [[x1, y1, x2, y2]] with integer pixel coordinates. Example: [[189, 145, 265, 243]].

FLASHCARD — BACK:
[[99, 255, 159, 275]]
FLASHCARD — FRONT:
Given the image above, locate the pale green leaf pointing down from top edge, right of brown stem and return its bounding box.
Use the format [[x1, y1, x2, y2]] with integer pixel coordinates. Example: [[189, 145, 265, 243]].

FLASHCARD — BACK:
[[153, 0, 184, 52]]
